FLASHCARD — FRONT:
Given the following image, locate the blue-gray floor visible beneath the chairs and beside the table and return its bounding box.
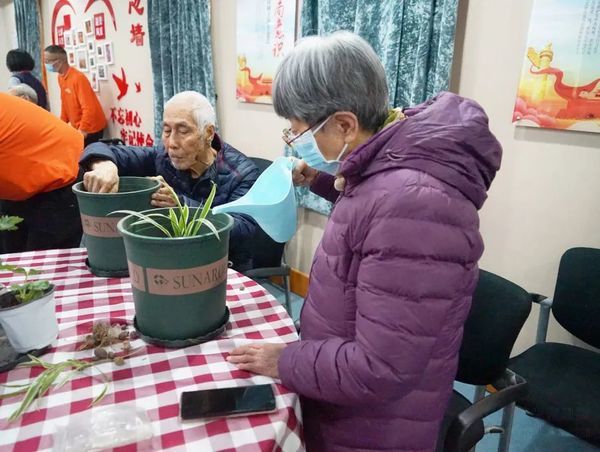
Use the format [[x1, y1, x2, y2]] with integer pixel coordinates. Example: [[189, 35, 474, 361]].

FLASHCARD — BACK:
[[261, 282, 600, 452]]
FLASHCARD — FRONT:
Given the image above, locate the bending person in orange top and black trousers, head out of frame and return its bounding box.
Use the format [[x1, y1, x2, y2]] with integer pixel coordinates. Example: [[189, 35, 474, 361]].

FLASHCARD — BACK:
[[0, 93, 83, 254]]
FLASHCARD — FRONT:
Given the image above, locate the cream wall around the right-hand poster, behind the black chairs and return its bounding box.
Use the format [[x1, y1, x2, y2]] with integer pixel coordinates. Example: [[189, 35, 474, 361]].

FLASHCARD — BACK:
[[454, 0, 600, 350]]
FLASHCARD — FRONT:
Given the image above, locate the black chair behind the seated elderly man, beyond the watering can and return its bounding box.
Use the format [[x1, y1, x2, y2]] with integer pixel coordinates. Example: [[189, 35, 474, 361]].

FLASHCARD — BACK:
[[244, 157, 292, 315]]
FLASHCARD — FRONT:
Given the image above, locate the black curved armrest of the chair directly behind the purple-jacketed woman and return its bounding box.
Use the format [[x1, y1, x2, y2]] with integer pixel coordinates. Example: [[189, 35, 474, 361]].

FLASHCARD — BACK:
[[444, 369, 527, 450]]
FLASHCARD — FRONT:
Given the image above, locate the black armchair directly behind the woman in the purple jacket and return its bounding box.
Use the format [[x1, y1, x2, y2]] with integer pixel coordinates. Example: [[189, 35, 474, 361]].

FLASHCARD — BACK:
[[437, 270, 531, 452]]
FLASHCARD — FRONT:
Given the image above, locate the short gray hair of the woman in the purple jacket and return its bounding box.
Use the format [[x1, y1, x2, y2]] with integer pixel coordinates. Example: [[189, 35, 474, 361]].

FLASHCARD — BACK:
[[273, 31, 389, 131]]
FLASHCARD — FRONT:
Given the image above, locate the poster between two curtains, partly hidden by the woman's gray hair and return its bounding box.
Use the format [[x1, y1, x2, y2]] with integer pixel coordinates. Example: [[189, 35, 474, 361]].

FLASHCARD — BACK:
[[236, 0, 296, 104]]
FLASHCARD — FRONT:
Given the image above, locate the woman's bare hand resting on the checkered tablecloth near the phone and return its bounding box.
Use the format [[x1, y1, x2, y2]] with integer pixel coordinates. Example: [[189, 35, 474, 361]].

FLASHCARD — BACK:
[[227, 344, 286, 378]]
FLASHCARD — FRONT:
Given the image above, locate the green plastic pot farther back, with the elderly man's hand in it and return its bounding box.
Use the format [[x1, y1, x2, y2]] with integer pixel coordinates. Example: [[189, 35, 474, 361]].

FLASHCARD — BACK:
[[73, 177, 160, 276]]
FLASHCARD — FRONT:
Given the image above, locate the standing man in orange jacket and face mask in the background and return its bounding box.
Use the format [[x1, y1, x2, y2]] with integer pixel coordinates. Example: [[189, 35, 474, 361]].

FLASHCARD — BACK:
[[44, 45, 106, 146]]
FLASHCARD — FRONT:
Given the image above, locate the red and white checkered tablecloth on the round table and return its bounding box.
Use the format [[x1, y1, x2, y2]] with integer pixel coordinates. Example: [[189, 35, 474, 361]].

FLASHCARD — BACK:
[[0, 249, 304, 452]]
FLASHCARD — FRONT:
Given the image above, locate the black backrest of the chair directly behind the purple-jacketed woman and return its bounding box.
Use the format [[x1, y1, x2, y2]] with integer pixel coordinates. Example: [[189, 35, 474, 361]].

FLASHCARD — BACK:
[[456, 270, 531, 385]]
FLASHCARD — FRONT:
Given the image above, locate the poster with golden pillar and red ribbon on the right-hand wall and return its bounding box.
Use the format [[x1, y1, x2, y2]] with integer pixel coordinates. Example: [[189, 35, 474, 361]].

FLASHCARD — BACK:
[[513, 0, 600, 133]]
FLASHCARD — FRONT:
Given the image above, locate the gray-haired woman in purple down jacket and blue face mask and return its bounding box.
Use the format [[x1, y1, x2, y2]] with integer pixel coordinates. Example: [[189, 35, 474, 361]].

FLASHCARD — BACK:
[[228, 32, 502, 451]]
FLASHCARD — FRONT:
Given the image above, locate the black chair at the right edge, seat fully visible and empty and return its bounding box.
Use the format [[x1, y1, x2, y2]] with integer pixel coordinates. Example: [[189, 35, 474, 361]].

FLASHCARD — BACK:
[[509, 248, 600, 447]]
